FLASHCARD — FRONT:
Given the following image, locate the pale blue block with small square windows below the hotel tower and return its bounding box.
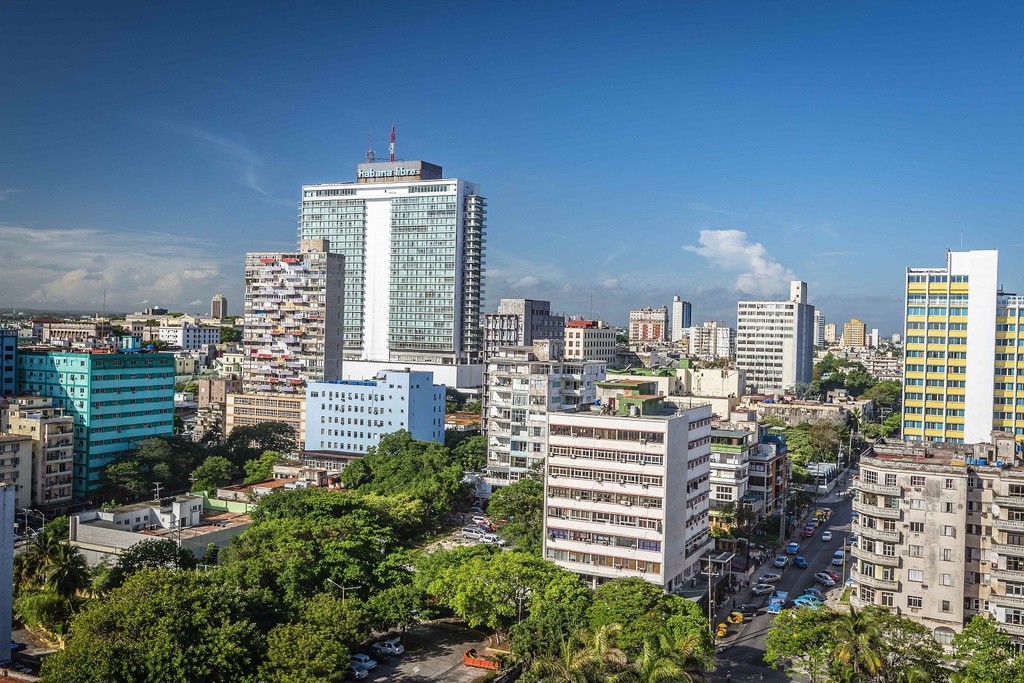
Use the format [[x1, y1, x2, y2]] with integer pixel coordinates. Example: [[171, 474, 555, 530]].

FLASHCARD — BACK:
[[304, 370, 444, 456]]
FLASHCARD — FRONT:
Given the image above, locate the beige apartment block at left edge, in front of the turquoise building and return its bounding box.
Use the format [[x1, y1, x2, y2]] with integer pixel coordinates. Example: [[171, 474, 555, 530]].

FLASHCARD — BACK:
[[0, 395, 75, 507]]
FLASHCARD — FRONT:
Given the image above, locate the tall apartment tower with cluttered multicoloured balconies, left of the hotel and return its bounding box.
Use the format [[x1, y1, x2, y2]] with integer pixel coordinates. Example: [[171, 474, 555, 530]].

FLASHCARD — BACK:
[[242, 240, 344, 393]]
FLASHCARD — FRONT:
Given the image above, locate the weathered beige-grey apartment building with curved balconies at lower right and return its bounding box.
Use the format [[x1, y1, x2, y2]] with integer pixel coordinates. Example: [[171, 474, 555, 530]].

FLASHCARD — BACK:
[[851, 432, 1024, 647]]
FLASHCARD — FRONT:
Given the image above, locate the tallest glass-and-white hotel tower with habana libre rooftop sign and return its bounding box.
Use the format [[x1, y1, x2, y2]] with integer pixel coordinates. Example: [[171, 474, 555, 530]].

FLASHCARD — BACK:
[[299, 156, 486, 387]]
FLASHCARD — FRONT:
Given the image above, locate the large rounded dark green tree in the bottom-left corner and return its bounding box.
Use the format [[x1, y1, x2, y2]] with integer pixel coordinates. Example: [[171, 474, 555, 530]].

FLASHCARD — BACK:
[[43, 569, 275, 683]]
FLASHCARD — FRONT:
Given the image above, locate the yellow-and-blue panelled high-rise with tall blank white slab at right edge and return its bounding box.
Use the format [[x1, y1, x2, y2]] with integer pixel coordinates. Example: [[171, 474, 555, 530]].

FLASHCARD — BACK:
[[903, 250, 1024, 443]]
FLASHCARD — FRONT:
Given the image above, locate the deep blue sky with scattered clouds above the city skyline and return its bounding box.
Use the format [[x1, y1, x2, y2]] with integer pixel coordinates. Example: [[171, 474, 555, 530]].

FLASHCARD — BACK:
[[0, 2, 1024, 333]]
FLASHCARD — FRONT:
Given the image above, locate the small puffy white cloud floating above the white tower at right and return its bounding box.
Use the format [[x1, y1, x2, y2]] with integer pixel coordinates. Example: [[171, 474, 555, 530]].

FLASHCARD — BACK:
[[683, 230, 797, 295]]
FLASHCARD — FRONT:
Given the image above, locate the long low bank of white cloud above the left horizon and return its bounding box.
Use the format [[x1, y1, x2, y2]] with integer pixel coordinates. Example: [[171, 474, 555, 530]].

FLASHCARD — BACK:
[[0, 224, 243, 310]]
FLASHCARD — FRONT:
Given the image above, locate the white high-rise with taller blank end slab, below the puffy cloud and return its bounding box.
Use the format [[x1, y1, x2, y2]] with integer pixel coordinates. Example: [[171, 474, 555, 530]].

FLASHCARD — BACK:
[[736, 281, 814, 393]]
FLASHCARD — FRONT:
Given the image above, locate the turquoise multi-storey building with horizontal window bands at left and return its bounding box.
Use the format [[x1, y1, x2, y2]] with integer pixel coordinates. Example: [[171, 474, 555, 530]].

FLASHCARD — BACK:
[[17, 348, 174, 498]]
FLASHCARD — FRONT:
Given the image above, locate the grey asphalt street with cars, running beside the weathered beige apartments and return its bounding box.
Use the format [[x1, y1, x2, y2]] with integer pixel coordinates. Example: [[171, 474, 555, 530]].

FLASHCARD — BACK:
[[710, 489, 853, 683]]
